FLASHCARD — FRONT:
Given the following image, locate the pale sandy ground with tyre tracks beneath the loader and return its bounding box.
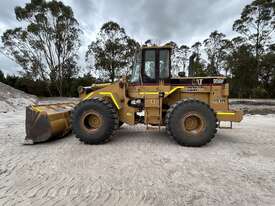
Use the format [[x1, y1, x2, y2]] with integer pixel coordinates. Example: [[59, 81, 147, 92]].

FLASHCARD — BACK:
[[0, 110, 275, 206]]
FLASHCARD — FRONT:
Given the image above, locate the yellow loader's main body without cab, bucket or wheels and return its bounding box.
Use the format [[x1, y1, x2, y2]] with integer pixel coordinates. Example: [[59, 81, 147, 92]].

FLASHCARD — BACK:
[[80, 77, 243, 126]]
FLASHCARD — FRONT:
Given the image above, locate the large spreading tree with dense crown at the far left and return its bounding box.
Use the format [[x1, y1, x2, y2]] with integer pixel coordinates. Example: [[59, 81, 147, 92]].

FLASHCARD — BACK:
[[2, 0, 80, 96]]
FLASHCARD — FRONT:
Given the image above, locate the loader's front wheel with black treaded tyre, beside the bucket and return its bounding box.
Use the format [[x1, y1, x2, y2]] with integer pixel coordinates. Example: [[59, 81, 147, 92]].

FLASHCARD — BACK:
[[72, 98, 118, 144]]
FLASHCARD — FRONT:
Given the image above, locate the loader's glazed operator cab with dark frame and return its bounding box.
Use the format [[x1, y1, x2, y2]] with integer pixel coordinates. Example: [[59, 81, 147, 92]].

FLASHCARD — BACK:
[[131, 47, 172, 84]]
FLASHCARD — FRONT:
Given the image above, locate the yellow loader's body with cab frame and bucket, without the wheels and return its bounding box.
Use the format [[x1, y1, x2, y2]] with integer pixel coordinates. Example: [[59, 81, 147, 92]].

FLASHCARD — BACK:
[[26, 47, 243, 143]]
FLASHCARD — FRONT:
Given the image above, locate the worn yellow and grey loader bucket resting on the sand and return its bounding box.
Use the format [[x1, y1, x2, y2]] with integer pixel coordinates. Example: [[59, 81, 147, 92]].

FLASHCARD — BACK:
[[25, 103, 76, 144]]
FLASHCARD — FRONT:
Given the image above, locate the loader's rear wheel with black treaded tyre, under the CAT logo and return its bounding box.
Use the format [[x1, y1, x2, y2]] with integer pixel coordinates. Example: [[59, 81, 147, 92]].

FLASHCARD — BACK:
[[165, 100, 217, 147]]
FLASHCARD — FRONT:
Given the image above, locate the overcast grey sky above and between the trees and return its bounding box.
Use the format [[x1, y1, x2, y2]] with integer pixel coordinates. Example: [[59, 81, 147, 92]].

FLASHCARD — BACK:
[[0, 0, 252, 74]]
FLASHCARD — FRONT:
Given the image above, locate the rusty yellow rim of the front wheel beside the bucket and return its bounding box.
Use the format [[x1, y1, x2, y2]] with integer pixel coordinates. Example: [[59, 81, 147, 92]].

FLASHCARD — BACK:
[[81, 111, 103, 133]]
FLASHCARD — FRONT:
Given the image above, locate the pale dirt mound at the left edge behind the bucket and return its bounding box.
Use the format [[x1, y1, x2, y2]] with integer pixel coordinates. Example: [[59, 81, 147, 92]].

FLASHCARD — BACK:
[[0, 82, 37, 113]]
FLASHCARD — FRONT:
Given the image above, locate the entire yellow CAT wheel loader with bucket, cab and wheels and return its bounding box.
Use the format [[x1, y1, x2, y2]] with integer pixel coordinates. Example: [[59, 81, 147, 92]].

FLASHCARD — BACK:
[[26, 46, 243, 147]]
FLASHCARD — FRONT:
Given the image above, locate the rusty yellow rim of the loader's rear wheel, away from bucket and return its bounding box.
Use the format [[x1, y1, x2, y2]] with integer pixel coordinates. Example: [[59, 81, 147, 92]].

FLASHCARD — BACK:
[[182, 112, 206, 135]]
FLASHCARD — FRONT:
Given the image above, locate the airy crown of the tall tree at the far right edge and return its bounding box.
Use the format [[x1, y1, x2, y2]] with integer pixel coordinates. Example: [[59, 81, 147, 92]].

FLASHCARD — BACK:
[[233, 0, 275, 70]]
